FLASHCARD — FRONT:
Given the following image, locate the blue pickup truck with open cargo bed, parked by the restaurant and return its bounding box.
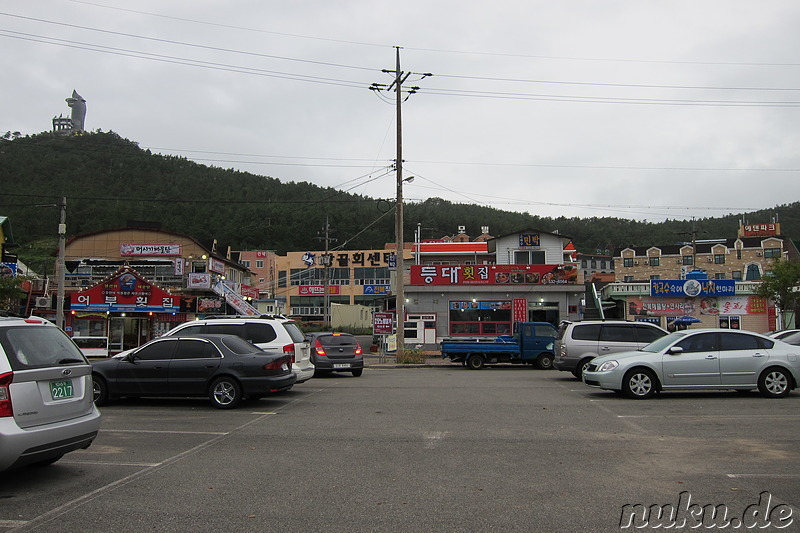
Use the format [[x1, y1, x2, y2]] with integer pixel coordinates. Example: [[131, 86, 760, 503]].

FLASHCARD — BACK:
[[441, 322, 558, 370]]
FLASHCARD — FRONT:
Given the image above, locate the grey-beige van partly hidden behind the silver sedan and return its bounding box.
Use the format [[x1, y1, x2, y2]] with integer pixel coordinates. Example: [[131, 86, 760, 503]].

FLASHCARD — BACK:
[[553, 320, 667, 379]]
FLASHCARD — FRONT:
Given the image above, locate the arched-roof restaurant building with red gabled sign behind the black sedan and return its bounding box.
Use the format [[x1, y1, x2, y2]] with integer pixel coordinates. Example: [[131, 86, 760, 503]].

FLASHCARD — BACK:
[[41, 227, 257, 354]]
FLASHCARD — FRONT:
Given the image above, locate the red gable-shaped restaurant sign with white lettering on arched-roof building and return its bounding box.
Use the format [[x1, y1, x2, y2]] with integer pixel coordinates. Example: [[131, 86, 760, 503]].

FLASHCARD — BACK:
[[70, 267, 180, 313]]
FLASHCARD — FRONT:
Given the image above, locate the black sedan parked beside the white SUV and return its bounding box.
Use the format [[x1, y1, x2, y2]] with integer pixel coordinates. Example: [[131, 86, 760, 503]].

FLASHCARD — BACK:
[[92, 335, 297, 409]]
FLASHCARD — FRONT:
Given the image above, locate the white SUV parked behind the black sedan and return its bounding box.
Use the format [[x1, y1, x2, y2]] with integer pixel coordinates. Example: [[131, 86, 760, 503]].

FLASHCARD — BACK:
[[164, 315, 314, 383]]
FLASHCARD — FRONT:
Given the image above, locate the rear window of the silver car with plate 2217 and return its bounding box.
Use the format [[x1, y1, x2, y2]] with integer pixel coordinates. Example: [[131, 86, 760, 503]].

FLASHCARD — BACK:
[[0, 327, 86, 370]]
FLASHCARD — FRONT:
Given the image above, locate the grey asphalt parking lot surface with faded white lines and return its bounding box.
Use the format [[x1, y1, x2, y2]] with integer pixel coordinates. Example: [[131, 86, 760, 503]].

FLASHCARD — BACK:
[[0, 361, 800, 532]]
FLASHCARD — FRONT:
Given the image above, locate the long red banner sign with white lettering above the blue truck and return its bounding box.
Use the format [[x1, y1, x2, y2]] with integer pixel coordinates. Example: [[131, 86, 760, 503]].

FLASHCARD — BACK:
[[411, 265, 578, 285]]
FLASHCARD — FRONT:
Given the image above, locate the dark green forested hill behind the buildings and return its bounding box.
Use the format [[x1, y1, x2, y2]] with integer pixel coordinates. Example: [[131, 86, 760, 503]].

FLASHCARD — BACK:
[[0, 132, 800, 260]]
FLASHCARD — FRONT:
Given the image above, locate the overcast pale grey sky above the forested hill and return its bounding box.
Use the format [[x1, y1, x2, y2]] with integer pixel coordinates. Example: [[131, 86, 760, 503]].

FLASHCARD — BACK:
[[0, 0, 800, 224]]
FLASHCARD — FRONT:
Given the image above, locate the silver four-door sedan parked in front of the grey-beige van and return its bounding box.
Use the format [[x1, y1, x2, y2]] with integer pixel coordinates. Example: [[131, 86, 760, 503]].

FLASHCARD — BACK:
[[583, 329, 800, 399]]
